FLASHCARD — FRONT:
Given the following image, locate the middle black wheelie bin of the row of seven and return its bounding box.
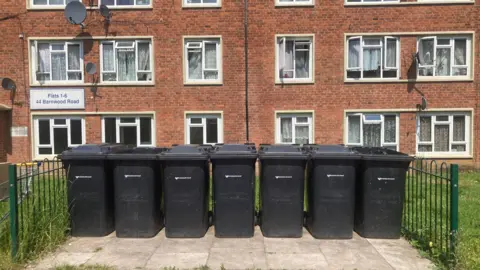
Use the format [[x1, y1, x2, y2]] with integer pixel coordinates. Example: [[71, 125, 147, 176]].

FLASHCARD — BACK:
[[210, 144, 257, 237]]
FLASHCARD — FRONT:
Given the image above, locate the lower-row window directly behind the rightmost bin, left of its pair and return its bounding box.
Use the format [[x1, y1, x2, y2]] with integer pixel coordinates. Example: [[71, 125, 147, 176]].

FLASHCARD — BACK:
[[347, 113, 398, 150]]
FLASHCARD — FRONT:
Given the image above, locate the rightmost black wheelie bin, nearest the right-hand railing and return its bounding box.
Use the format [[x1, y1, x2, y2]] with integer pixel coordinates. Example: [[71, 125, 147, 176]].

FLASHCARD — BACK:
[[355, 147, 413, 239]]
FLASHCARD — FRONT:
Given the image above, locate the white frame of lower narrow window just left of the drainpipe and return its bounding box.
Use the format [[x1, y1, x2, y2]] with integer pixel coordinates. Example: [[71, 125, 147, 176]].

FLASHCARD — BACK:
[[185, 112, 223, 145]]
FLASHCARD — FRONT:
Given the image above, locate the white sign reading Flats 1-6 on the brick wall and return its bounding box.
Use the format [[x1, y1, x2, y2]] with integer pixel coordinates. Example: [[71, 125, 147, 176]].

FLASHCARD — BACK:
[[30, 88, 85, 110]]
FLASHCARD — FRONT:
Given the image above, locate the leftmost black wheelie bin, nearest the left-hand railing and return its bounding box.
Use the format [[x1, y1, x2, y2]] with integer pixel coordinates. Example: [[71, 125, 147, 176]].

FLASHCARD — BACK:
[[60, 144, 126, 236]]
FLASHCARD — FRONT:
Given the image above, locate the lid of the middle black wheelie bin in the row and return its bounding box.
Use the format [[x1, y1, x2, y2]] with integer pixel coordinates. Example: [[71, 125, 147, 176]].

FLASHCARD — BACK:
[[210, 143, 257, 159]]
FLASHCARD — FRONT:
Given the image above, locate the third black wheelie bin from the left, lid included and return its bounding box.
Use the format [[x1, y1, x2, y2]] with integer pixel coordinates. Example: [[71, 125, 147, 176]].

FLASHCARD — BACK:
[[159, 145, 211, 238]]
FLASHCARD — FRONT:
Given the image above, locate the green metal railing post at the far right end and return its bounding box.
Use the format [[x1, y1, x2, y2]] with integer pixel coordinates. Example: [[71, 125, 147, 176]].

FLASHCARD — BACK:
[[450, 164, 458, 253]]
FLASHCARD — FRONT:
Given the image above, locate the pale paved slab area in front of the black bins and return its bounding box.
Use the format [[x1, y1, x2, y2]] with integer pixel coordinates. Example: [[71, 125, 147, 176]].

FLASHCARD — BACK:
[[31, 227, 433, 270]]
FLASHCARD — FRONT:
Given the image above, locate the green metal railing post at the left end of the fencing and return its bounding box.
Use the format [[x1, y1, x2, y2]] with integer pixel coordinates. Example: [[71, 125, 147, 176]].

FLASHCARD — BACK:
[[8, 164, 18, 261]]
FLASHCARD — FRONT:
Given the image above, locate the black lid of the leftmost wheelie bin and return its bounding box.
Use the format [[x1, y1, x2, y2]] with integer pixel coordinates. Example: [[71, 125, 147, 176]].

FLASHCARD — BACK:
[[59, 143, 130, 160]]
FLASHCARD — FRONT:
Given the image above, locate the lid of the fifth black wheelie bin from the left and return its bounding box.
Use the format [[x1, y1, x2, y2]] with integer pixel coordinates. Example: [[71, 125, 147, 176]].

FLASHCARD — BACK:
[[258, 144, 308, 159]]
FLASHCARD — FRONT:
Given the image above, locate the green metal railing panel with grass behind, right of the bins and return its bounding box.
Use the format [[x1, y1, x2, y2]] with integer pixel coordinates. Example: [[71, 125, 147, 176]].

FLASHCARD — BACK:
[[402, 159, 458, 265]]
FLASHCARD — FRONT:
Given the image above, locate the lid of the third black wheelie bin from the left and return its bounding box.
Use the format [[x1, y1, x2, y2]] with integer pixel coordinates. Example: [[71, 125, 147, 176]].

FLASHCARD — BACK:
[[157, 144, 212, 160]]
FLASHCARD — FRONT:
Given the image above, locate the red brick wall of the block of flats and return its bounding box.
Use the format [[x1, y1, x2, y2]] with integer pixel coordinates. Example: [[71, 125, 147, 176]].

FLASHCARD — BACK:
[[0, 0, 480, 167]]
